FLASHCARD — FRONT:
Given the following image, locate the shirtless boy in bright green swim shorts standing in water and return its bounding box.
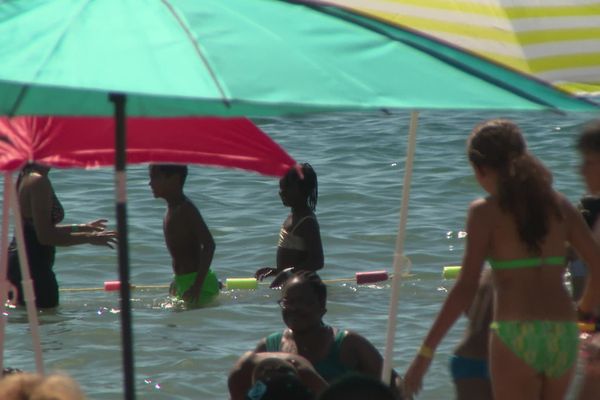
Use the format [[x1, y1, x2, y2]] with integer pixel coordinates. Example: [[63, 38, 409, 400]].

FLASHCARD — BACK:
[[149, 164, 219, 306]]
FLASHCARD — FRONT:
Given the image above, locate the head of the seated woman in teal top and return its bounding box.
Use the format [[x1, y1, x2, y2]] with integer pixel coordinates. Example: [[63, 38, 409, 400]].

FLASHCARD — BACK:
[[278, 271, 327, 332]]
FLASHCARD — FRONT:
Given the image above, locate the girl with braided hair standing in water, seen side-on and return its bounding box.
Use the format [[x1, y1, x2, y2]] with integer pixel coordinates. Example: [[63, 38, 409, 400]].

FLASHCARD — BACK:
[[255, 163, 324, 287]]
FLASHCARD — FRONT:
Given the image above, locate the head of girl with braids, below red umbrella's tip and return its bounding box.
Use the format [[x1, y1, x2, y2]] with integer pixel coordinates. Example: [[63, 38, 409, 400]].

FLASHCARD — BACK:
[[279, 163, 319, 211]]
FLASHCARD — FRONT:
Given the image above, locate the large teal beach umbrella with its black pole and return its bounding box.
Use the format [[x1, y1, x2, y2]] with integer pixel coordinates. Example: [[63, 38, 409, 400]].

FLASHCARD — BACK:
[[0, 0, 597, 399]]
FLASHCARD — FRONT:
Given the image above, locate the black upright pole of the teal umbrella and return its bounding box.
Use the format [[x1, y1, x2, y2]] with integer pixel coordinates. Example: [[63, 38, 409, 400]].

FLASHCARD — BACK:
[[109, 94, 135, 400]]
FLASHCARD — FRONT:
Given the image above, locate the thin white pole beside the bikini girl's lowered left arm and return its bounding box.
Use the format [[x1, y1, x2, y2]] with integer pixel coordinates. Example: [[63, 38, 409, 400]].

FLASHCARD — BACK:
[[381, 111, 419, 384]]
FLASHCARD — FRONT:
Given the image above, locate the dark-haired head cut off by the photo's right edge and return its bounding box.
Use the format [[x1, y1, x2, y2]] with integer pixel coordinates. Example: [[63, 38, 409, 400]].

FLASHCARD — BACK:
[[577, 120, 600, 195]]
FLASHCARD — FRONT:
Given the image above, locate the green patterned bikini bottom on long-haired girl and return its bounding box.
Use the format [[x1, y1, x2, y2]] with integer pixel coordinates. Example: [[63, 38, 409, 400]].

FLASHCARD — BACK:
[[490, 321, 579, 378]]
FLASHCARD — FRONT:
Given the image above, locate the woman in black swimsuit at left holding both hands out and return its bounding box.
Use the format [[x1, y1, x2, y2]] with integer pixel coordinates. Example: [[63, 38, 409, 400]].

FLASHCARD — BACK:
[[8, 164, 117, 308]]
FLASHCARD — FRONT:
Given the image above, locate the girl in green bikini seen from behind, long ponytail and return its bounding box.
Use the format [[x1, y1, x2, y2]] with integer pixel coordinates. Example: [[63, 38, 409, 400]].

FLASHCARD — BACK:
[[404, 120, 600, 400]]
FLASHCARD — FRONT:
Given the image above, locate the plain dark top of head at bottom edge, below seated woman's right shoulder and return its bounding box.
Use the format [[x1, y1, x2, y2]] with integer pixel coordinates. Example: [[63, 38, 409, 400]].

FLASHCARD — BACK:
[[319, 373, 395, 400]]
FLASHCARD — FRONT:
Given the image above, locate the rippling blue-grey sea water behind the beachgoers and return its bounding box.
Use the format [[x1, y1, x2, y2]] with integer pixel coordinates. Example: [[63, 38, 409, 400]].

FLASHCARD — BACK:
[[4, 111, 594, 399]]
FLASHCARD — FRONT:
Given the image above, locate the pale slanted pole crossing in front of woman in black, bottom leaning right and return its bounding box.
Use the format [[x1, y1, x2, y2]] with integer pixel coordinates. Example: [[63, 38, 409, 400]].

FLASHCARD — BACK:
[[4, 174, 44, 374]]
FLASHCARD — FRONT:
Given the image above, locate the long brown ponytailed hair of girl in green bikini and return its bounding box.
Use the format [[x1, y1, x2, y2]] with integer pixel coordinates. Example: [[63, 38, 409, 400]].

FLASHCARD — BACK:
[[467, 119, 562, 253]]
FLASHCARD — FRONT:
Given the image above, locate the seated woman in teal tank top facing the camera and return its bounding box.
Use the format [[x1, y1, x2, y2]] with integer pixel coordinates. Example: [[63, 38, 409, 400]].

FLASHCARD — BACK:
[[229, 271, 399, 400]]
